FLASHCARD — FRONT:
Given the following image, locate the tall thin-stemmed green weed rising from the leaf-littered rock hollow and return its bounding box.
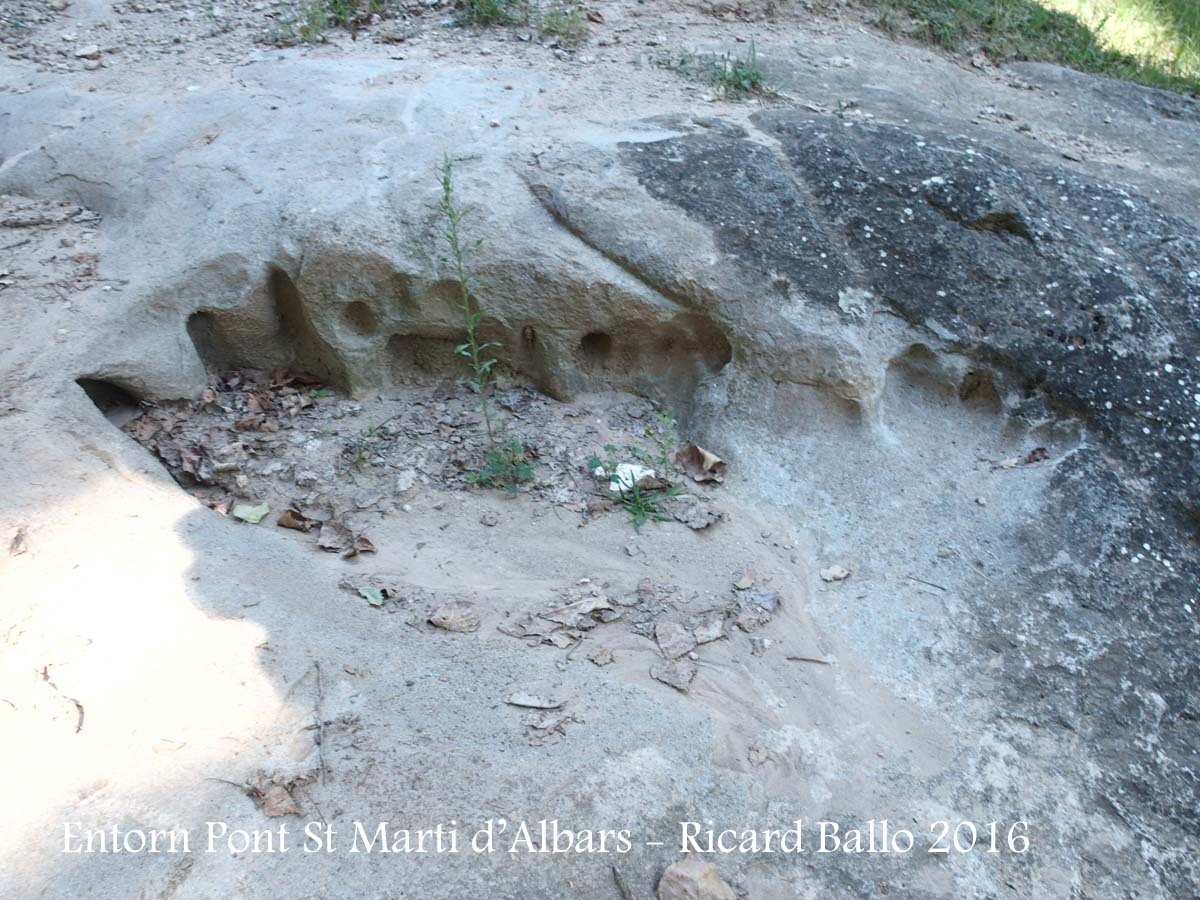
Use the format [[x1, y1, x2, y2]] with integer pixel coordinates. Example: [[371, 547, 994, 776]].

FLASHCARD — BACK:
[[439, 155, 533, 492]]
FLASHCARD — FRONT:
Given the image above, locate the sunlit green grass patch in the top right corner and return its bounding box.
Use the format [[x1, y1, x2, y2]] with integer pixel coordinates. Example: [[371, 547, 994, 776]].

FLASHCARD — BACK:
[[874, 0, 1200, 94]]
